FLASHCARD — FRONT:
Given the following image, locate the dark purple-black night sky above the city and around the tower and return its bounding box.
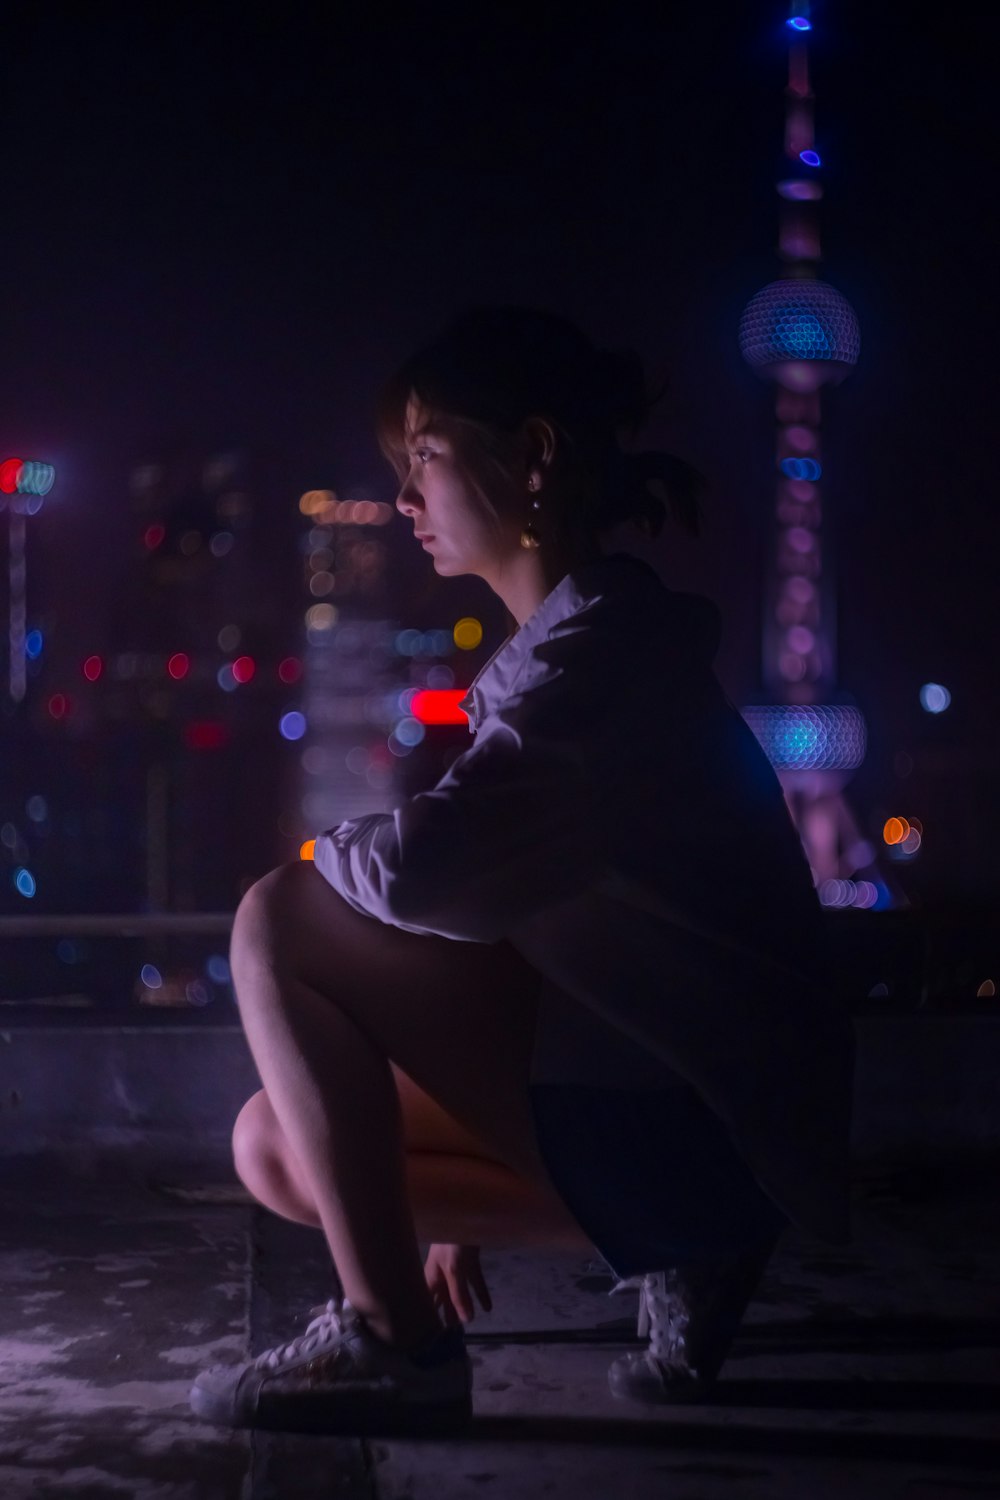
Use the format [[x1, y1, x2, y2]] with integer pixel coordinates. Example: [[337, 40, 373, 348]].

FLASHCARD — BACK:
[[0, 0, 1000, 882]]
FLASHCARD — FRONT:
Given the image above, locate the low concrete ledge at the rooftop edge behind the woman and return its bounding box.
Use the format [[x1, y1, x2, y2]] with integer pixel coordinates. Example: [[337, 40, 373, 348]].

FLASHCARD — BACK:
[[0, 1016, 1000, 1161]]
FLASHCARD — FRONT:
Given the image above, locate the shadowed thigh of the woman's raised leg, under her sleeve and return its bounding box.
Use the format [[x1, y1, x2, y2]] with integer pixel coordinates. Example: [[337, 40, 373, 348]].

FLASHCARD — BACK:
[[232, 863, 552, 1187]]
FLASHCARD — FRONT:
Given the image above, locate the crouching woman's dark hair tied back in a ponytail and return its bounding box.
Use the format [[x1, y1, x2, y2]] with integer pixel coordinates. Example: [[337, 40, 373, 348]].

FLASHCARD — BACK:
[[376, 308, 705, 537]]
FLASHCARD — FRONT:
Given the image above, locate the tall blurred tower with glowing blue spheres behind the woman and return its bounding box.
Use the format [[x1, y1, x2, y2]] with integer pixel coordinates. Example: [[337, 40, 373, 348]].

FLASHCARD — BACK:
[[739, 3, 895, 908]]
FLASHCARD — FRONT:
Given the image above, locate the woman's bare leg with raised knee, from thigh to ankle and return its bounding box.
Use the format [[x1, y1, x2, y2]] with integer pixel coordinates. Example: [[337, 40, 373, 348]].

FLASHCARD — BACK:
[[232, 864, 593, 1349]]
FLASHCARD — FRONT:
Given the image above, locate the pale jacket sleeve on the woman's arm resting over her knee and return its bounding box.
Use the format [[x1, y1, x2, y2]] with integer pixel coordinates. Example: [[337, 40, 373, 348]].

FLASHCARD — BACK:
[[315, 636, 603, 944]]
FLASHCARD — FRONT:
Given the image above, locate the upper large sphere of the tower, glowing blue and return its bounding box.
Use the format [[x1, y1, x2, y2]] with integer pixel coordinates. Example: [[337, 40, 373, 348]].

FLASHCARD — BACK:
[[739, 278, 861, 390]]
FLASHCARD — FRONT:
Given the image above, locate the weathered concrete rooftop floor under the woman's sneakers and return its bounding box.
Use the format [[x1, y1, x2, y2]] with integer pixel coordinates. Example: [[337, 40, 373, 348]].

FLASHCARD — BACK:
[[0, 1154, 1000, 1500]]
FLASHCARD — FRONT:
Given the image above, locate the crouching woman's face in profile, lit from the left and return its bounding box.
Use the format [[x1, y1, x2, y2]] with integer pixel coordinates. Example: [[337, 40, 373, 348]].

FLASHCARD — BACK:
[[396, 398, 526, 581]]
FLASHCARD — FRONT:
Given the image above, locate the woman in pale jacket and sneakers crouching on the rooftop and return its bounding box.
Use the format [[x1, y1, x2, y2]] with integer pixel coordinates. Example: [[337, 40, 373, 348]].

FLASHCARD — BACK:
[[192, 308, 853, 1433]]
